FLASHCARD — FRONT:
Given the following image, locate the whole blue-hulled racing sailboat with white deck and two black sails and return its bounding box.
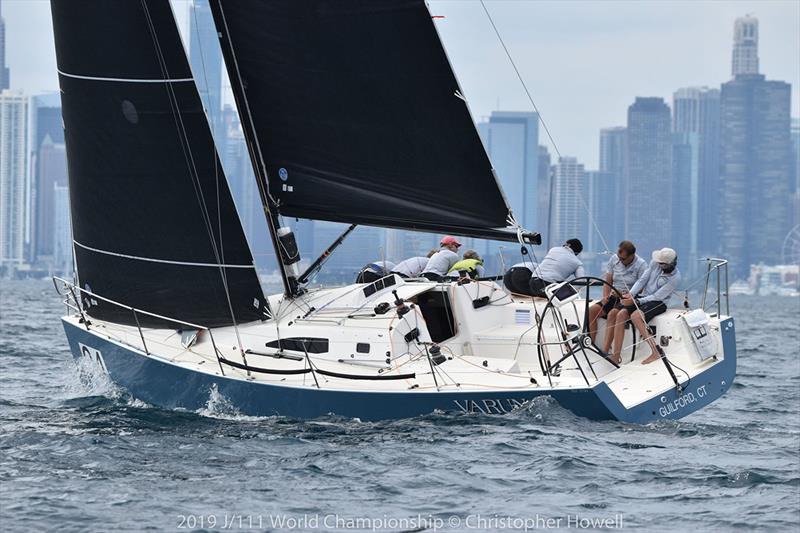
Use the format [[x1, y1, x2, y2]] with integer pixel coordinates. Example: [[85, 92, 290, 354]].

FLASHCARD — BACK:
[[52, 0, 736, 423]]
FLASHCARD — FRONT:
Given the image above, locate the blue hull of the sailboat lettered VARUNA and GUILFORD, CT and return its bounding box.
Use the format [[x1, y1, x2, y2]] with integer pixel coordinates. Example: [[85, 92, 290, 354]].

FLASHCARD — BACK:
[[63, 318, 736, 423]]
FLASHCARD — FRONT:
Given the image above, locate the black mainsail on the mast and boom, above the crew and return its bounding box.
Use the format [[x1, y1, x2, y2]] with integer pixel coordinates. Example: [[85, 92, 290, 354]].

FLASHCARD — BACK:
[[210, 0, 536, 239]]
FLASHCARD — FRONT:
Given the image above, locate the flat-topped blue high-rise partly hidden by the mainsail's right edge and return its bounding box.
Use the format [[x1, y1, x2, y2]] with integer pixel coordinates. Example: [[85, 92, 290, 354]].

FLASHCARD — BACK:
[[478, 111, 539, 231]]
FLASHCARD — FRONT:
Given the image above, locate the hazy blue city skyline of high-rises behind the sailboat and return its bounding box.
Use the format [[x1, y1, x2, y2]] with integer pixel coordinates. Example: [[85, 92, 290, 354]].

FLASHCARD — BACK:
[[0, 2, 800, 282]]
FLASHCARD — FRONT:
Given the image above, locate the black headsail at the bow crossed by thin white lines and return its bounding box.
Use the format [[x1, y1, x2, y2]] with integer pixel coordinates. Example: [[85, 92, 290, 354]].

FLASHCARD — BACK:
[[51, 0, 266, 326]]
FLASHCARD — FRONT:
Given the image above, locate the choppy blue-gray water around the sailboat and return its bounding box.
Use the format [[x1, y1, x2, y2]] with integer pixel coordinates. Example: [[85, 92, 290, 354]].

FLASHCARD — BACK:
[[0, 281, 800, 531]]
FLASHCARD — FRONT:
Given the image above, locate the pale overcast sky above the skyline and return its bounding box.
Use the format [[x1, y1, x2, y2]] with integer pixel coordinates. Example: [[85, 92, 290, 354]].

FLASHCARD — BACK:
[[2, 0, 800, 169]]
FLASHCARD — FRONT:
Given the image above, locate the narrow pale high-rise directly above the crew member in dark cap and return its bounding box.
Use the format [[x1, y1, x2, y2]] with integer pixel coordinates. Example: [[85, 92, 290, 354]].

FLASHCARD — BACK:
[[549, 157, 588, 246]]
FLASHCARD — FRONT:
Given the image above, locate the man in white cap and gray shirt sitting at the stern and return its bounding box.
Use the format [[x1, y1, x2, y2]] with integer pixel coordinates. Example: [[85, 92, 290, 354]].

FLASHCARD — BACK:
[[609, 248, 681, 365]]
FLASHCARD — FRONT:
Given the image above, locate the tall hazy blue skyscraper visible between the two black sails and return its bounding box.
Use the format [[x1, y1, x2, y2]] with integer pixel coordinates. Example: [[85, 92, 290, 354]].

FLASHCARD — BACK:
[[189, 0, 226, 139]]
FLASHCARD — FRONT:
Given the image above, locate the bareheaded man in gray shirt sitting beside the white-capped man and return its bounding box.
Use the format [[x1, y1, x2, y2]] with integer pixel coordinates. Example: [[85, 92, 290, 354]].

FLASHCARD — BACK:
[[589, 241, 647, 353]]
